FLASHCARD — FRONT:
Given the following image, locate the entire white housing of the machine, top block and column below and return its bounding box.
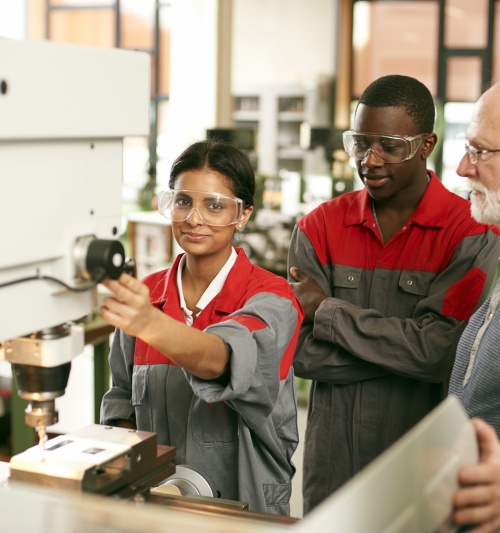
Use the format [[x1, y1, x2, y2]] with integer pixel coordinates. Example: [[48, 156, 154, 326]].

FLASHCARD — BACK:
[[0, 39, 150, 344]]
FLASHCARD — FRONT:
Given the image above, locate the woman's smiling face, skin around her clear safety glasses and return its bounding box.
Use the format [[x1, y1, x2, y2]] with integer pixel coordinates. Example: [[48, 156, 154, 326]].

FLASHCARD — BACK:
[[172, 169, 253, 261]]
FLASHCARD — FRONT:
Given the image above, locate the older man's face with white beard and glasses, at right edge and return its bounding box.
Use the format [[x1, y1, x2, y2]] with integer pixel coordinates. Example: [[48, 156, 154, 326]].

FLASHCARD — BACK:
[[457, 86, 500, 225]]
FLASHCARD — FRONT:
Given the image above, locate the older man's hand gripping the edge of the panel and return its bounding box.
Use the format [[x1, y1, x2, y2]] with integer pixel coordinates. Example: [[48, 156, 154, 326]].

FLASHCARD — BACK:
[[453, 418, 500, 533]]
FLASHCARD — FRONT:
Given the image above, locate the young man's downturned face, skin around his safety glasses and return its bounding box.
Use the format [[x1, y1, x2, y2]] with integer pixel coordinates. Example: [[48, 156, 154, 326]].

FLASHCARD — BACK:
[[353, 104, 427, 201]]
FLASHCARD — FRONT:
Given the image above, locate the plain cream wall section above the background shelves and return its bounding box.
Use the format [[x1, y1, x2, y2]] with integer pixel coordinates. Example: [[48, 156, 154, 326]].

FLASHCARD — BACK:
[[232, 0, 337, 86]]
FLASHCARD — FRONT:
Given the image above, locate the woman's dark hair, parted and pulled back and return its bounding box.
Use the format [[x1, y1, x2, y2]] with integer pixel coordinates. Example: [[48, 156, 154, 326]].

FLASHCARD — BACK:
[[168, 139, 255, 207]]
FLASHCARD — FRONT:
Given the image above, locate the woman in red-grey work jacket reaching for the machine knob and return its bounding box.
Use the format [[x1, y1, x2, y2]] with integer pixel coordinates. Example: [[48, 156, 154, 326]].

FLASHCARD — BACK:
[[97, 141, 303, 514]]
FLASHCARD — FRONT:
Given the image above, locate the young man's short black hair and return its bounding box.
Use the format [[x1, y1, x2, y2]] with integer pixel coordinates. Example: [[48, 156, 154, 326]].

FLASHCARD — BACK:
[[358, 74, 436, 133]]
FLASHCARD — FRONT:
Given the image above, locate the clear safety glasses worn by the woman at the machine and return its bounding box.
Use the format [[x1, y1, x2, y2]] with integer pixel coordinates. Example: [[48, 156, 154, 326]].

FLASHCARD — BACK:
[[158, 189, 244, 226]]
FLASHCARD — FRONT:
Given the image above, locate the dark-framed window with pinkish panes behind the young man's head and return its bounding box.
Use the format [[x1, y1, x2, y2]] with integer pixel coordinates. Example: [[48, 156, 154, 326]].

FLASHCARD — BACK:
[[351, 0, 500, 192]]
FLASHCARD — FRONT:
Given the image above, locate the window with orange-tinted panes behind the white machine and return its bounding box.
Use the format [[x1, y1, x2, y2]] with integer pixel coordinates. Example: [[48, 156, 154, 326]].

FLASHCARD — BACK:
[[46, 0, 170, 209]]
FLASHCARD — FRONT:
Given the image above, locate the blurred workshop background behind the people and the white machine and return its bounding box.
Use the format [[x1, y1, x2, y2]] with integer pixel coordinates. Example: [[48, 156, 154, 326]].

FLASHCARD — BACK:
[[0, 0, 492, 274]]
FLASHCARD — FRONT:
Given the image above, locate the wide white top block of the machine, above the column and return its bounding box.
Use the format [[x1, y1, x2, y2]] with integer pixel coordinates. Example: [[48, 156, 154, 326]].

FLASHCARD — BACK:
[[0, 38, 150, 141]]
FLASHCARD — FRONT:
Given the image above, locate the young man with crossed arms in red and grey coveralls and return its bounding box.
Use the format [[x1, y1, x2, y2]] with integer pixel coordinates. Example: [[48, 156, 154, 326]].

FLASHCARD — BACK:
[[289, 75, 500, 513]]
